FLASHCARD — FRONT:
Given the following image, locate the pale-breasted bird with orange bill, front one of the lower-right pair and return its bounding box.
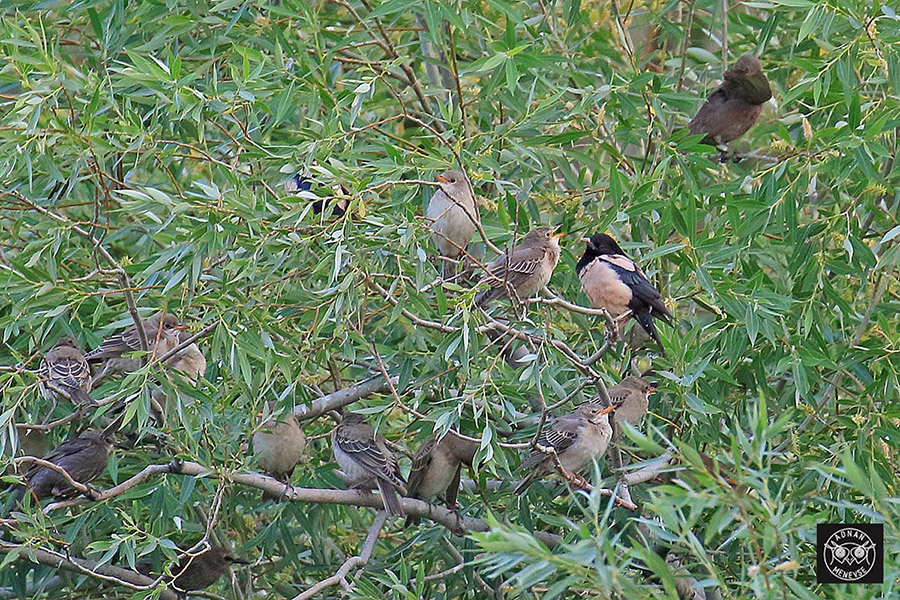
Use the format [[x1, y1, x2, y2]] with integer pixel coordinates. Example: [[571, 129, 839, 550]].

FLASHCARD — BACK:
[[516, 403, 616, 494]]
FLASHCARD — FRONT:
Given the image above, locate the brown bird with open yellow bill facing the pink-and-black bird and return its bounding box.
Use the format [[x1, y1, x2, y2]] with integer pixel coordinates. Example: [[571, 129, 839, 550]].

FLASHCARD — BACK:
[[475, 227, 565, 306]]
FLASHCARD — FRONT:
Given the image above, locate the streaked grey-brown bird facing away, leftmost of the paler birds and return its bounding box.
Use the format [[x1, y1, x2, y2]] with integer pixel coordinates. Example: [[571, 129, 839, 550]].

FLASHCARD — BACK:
[[38, 337, 96, 405]]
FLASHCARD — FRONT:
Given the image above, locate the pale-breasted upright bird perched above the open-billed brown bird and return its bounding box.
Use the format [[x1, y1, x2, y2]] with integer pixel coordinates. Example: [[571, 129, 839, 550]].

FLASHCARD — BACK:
[[425, 171, 481, 278]]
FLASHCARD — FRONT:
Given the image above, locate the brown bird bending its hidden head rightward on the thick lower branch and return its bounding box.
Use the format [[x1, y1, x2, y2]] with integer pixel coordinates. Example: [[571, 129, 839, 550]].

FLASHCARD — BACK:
[[406, 431, 478, 525]]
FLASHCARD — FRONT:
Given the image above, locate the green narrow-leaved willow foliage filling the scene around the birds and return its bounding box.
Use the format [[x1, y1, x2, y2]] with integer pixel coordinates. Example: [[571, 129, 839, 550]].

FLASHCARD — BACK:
[[0, 0, 900, 599]]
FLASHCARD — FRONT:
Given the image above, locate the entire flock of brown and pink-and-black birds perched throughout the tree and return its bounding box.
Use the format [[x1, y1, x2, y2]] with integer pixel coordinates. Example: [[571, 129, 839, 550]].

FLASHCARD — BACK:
[[4, 55, 772, 594]]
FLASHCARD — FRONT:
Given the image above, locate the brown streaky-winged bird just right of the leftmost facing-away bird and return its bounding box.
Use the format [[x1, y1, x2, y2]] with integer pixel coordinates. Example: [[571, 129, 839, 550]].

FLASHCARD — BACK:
[[84, 313, 184, 379]]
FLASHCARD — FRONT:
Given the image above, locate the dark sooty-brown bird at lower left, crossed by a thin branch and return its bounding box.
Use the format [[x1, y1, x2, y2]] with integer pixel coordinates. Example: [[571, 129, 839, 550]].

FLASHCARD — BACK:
[[16, 430, 112, 500]]
